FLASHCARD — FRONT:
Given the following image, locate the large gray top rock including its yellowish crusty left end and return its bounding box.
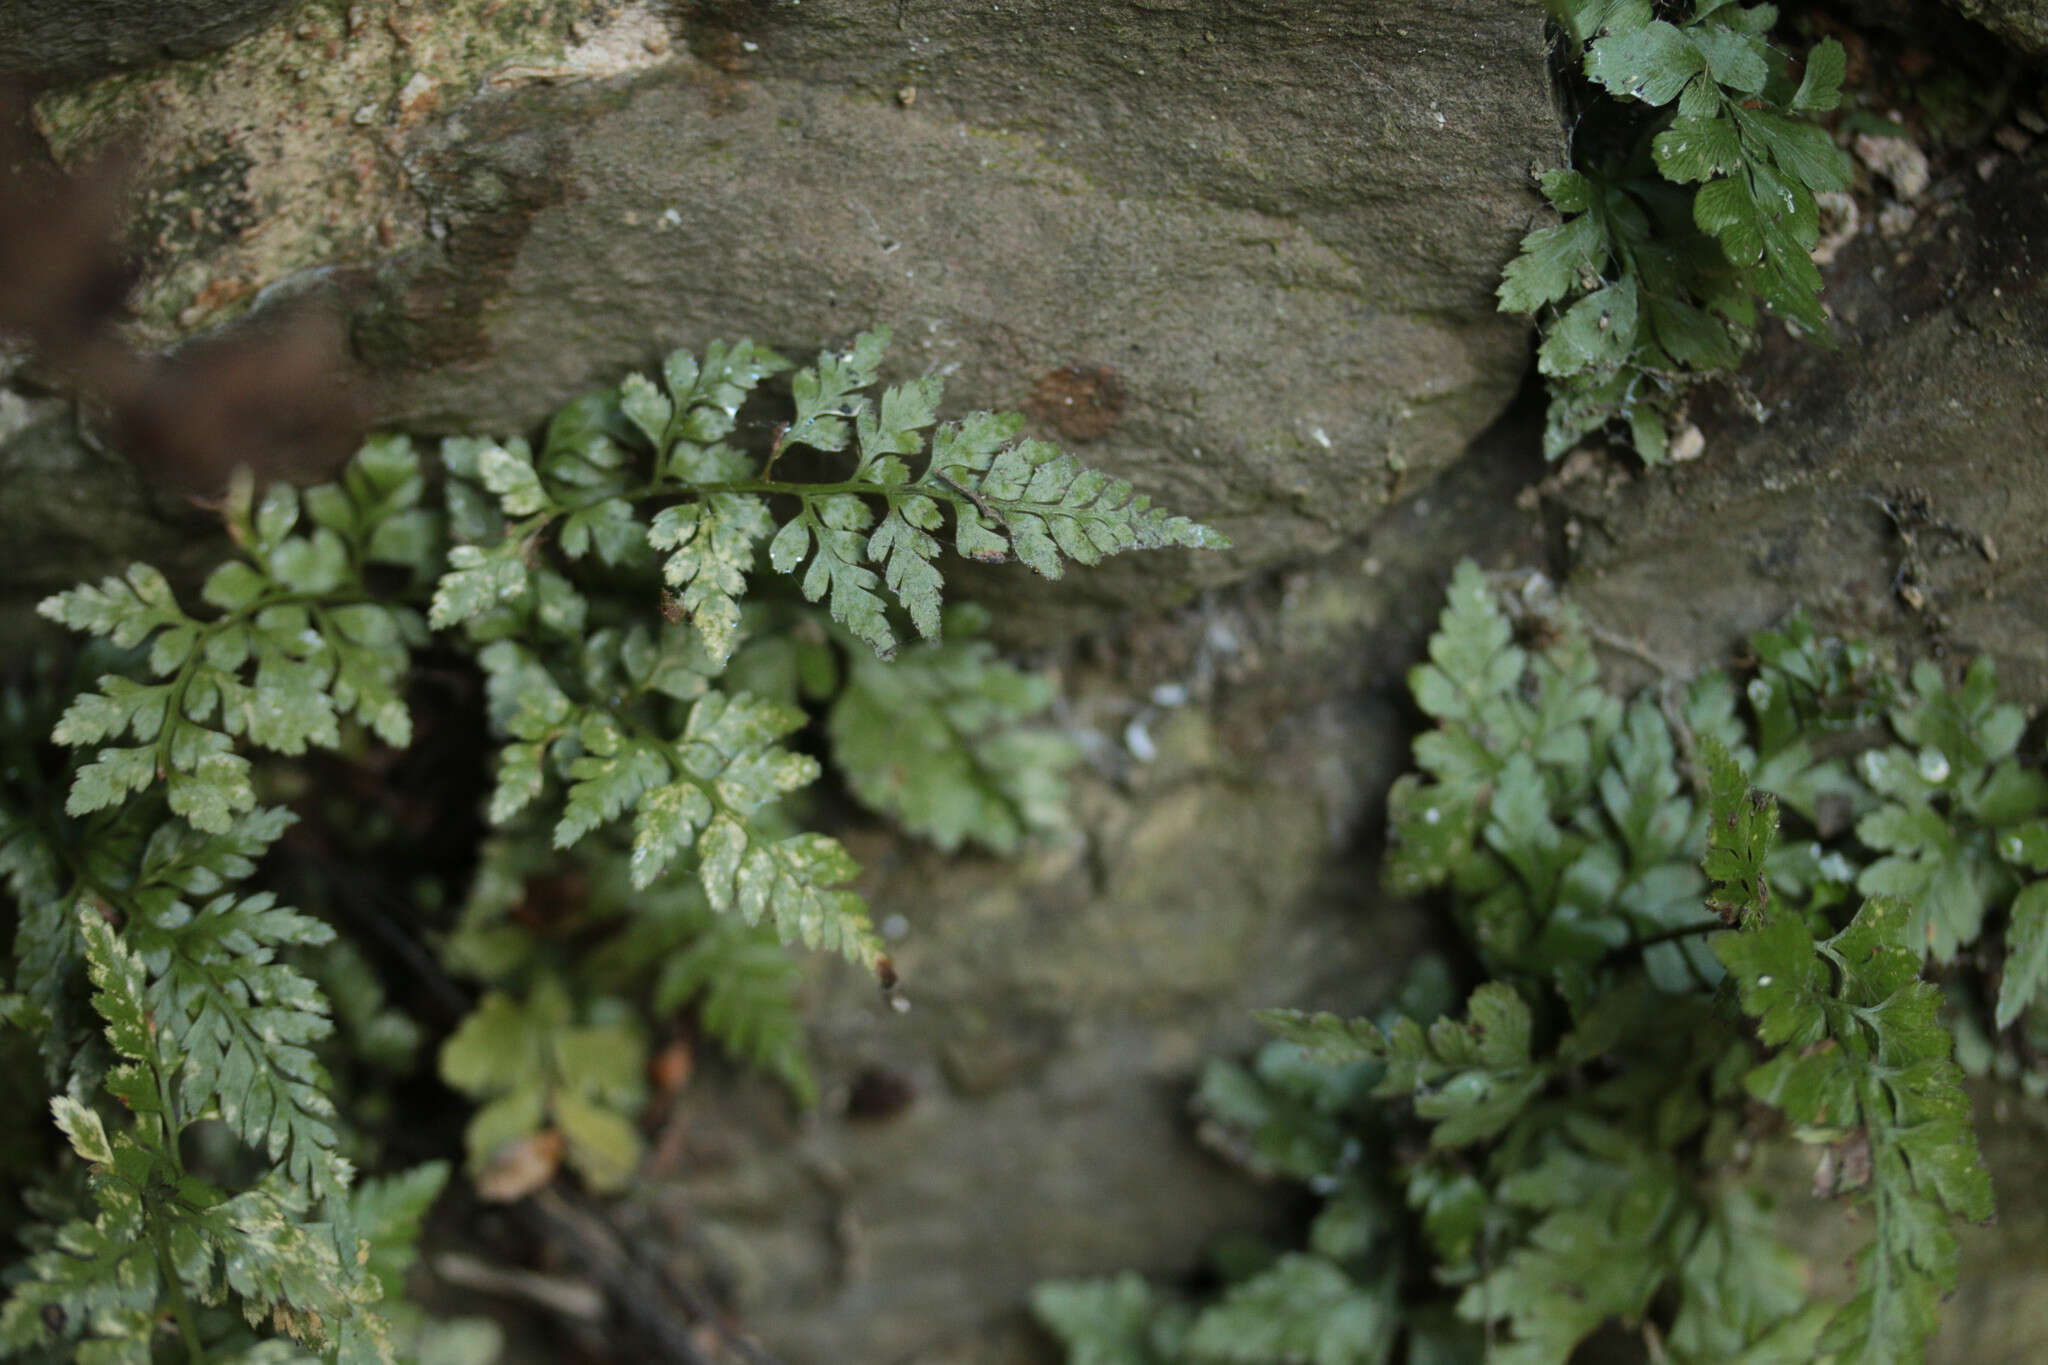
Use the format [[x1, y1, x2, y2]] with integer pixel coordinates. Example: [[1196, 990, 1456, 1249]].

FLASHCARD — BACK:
[[16, 0, 1563, 634]]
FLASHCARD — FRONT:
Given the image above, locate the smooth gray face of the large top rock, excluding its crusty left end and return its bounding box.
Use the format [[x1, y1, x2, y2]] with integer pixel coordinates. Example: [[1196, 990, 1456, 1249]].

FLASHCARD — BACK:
[[379, 4, 1559, 606]]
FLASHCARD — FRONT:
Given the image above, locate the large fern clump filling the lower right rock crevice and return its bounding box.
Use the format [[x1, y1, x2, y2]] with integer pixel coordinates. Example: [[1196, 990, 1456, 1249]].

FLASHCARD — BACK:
[[1034, 563, 2048, 1365]]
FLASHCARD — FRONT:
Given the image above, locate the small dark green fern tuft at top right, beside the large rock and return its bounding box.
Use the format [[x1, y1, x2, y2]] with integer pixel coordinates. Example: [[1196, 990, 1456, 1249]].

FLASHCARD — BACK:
[[1499, 0, 1849, 465]]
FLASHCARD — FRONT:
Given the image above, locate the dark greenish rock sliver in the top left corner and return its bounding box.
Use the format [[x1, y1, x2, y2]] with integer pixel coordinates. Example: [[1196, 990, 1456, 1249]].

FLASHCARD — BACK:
[[0, 0, 299, 84]]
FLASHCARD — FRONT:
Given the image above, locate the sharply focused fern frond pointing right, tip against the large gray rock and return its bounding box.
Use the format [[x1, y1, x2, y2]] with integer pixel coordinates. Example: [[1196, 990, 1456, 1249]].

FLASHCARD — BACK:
[[432, 329, 1227, 663]]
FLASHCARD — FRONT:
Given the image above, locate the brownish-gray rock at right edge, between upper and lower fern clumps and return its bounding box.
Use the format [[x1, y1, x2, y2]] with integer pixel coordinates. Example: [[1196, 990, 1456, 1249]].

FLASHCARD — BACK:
[[1565, 151, 2048, 698]]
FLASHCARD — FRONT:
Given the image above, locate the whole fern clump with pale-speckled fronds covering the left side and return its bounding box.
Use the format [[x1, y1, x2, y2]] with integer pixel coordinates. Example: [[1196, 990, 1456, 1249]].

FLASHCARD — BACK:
[[0, 332, 1223, 1363]]
